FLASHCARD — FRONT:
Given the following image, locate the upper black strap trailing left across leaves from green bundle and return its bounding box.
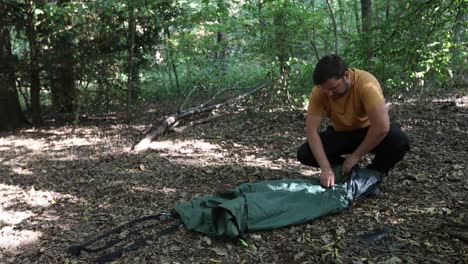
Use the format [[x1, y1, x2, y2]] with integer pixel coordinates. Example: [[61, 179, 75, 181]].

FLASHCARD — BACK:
[[68, 213, 172, 257]]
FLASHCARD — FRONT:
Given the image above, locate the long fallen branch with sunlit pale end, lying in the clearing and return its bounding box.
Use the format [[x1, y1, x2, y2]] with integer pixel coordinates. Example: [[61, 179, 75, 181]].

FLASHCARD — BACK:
[[132, 82, 269, 151]]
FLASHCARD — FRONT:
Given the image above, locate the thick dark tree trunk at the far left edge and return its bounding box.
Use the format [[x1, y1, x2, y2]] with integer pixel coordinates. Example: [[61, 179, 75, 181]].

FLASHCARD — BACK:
[[0, 2, 26, 130]]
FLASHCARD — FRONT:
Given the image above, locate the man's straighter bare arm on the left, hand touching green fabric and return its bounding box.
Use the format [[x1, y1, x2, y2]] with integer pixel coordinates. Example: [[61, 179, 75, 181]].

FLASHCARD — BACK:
[[306, 115, 335, 188]]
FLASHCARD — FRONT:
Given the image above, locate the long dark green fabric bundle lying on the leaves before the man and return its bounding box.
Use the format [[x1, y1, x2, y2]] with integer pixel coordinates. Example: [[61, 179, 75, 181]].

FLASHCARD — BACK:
[[175, 167, 382, 238]]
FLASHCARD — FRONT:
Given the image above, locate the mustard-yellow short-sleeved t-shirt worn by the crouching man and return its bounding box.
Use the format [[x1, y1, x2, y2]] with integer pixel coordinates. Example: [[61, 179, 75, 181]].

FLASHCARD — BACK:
[[307, 68, 385, 131]]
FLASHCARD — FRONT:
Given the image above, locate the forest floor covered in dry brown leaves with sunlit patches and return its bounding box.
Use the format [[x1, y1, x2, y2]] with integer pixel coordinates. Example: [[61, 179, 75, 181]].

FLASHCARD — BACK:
[[0, 94, 468, 264]]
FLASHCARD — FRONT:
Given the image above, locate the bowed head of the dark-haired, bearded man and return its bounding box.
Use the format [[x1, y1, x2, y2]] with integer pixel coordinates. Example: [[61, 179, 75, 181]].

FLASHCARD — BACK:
[[314, 54, 350, 99]]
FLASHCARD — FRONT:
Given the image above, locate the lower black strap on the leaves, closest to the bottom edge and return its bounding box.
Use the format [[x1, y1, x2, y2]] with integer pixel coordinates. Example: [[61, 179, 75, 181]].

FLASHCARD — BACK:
[[96, 220, 183, 263]]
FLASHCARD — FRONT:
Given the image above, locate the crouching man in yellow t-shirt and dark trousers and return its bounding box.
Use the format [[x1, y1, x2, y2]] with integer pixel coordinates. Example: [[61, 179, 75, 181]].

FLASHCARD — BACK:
[[297, 55, 409, 188]]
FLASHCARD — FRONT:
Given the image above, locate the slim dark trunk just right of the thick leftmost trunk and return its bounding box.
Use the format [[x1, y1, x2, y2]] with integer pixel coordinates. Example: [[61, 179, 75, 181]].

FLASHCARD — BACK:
[[26, 1, 42, 125]]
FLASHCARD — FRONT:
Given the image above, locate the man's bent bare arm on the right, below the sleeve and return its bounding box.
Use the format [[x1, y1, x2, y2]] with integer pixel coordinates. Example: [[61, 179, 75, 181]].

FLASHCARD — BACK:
[[343, 104, 390, 174]]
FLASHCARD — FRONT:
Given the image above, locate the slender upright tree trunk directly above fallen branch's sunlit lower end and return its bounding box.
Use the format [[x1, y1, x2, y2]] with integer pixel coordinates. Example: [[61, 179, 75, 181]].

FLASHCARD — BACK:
[[127, 0, 136, 116]]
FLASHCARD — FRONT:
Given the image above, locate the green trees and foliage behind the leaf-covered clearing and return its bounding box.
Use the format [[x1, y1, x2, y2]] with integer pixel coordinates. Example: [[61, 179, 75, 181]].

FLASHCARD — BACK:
[[0, 0, 467, 129]]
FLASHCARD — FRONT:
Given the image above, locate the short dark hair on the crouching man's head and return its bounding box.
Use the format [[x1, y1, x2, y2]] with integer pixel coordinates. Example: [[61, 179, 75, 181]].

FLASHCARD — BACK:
[[314, 54, 348, 85]]
